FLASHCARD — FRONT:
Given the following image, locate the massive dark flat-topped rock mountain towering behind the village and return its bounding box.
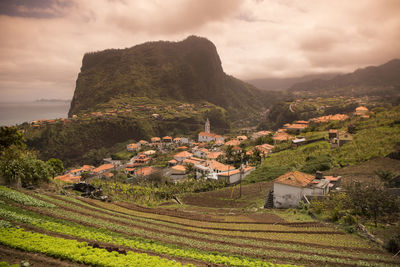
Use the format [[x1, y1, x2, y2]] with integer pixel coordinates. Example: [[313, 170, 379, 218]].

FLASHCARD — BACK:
[[68, 36, 265, 116]]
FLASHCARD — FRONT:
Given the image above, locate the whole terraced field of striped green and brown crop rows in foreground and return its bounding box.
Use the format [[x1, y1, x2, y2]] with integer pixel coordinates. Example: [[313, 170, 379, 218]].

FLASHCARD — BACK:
[[0, 187, 400, 266]]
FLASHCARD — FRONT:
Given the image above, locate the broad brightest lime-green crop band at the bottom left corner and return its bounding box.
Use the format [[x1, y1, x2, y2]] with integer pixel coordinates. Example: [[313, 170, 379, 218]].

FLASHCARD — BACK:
[[0, 228, 187, 266]]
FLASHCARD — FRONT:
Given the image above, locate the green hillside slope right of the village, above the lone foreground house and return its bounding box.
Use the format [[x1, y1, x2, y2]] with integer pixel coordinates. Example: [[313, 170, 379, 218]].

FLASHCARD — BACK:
[[245, 107, 400, 183]]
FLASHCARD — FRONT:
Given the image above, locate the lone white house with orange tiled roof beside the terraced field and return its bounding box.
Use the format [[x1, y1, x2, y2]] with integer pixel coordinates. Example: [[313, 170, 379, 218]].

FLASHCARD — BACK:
[[272, 171, 330, 208]]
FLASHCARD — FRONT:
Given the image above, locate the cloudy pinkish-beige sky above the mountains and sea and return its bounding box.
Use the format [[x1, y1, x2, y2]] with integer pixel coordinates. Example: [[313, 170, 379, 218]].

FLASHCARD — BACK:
[[0, 0, 400, 102]]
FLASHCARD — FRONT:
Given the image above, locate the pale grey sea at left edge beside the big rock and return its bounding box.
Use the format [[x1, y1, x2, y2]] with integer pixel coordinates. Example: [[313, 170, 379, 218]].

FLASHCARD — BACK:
[[0, 101, 70, 126]]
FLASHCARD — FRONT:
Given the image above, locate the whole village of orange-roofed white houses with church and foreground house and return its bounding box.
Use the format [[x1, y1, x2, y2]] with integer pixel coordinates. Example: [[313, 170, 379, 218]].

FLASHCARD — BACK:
[[54, 106, 371, 208]]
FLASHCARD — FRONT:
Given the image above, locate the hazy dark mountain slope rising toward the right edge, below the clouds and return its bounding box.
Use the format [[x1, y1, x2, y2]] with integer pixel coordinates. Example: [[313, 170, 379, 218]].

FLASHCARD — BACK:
[[289, 59, 400, 96]]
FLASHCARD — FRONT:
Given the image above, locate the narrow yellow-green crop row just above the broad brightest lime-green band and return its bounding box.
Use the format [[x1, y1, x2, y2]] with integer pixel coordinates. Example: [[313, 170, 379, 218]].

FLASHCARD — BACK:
[[0, 203, 290, 266]]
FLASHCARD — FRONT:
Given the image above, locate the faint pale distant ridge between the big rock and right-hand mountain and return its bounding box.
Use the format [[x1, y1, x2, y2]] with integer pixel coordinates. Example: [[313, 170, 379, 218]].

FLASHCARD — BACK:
[[247, 73, 338, 91]]
